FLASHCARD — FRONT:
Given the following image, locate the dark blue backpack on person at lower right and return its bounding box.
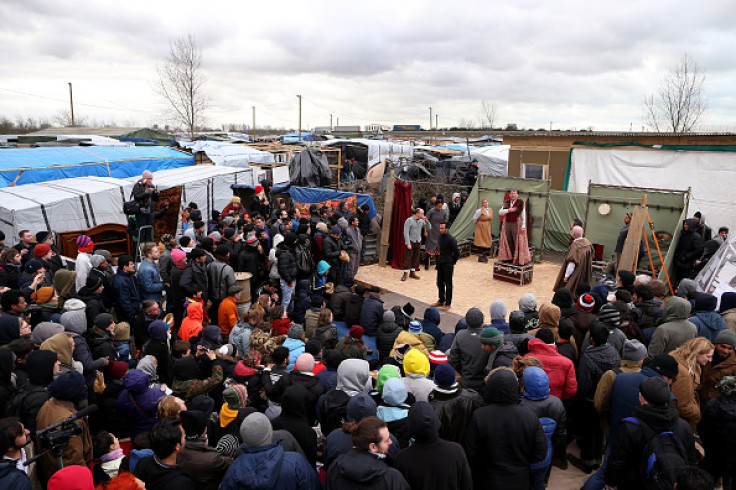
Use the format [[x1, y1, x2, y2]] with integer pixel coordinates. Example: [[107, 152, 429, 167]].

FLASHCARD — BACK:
[[623, 417, 688, 490]]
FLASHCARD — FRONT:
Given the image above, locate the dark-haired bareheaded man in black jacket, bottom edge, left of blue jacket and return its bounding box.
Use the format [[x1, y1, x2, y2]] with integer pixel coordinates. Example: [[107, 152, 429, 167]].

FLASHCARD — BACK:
[[134, 418, 198, 490]]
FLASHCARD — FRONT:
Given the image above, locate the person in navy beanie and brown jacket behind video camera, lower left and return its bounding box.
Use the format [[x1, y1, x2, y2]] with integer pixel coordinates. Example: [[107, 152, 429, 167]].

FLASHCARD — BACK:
[[36, 371, 92, 484]]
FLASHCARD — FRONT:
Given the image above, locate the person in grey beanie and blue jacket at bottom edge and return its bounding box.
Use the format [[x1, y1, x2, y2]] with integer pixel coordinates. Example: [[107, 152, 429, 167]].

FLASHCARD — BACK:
[[220, 412, 321, 490]]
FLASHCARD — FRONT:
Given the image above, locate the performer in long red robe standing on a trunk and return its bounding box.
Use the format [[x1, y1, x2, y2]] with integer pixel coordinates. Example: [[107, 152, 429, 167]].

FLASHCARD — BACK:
[[498, 189, 532, 265]]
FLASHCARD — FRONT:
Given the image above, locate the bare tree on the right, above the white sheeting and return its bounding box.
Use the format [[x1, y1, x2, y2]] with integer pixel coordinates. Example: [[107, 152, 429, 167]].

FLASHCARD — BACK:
[[643, 54, 708, 133]]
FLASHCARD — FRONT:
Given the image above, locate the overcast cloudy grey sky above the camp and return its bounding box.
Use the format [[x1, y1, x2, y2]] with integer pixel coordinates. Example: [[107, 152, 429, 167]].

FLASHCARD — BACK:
[[0, 0, 736, 131]]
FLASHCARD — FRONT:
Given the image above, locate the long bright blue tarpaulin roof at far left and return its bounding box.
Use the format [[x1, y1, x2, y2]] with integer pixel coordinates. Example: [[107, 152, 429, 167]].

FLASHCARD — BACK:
[[0, 146, 194, 187]]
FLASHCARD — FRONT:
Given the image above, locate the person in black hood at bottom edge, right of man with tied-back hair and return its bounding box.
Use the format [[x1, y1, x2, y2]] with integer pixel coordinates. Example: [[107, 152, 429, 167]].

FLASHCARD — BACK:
[[394, 402, 473, 490]]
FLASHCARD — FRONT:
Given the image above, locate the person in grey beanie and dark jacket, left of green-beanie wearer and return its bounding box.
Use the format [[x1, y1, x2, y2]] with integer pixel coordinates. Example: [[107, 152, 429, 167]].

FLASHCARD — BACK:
[[448, 308, 488, 391]]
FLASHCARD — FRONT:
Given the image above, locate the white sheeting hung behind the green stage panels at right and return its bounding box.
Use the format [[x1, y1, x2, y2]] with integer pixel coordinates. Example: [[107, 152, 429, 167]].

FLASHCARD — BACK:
[[567, 146, 736, 230]]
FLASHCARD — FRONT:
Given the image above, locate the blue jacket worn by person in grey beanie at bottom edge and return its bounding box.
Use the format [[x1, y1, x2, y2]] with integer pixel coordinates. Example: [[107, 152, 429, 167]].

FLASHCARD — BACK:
[[220, 443, 322, 490]]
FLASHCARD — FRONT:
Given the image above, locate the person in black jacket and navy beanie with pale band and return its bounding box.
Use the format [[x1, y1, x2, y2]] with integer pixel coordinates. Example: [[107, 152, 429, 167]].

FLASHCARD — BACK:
[[428, 364, 485, 443]]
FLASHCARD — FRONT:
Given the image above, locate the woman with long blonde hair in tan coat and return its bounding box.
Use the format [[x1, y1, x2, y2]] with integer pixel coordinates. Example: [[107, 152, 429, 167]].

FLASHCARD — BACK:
[[670, 337, 714, 431]]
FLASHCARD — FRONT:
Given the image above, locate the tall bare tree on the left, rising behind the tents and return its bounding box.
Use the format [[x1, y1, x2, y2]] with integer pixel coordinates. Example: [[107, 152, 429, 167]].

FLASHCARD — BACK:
[[156, 34, 207, 138]]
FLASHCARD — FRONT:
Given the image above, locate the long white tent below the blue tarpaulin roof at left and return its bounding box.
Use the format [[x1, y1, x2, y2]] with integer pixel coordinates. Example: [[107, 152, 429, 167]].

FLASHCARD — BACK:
[[0, 165, 253, 244]]
